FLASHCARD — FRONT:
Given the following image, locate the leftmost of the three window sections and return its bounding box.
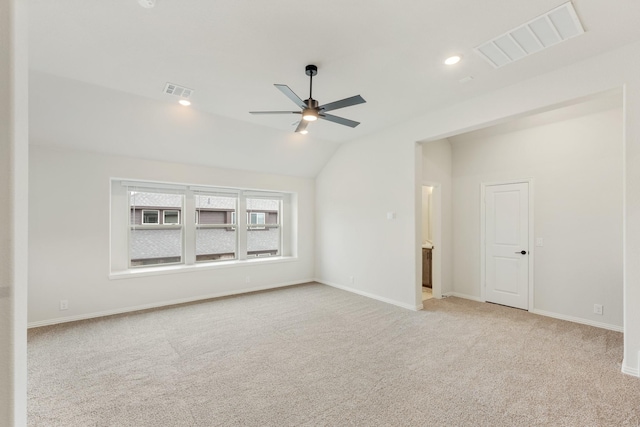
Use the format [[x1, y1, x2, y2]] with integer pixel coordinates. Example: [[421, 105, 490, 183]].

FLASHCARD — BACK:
[[128, 189, 184, 267]]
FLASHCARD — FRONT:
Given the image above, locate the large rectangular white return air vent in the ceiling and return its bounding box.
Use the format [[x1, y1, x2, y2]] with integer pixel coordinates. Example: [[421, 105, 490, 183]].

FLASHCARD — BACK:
[[474, 2, 584, 68]]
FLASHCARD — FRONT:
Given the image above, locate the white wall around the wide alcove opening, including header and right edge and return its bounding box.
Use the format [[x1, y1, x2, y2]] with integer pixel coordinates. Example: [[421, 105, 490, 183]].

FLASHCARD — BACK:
[[316, 39, 640, 375]]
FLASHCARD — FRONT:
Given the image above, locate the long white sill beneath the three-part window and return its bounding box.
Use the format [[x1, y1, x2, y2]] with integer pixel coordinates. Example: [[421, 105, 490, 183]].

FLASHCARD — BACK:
[[109, 256, 298, 280]]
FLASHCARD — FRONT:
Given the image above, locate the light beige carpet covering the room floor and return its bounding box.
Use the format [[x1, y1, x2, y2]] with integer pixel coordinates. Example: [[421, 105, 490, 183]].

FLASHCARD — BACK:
[[28, 284, 640, 427]]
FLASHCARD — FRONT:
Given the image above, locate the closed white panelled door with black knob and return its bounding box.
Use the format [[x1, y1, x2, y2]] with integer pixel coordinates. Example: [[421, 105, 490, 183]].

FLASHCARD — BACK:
[[485, 182, 529, 310]]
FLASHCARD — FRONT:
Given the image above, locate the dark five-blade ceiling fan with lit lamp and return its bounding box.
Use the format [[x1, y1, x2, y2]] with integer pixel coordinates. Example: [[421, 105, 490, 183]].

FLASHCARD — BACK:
[[250, 65, 367, 133]]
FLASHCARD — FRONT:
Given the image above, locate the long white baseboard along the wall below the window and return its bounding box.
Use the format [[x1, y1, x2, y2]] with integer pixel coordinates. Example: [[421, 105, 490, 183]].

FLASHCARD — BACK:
[[27, 279, 315, 328]]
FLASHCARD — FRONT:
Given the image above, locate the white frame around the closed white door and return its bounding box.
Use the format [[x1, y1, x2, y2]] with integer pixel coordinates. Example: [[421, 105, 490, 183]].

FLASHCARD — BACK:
[[480, 178, 535, 311]]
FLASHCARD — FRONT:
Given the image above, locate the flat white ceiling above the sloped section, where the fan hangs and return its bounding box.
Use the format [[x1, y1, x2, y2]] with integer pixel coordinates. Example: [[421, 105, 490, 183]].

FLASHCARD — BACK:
[[29, 0, 640, 142]]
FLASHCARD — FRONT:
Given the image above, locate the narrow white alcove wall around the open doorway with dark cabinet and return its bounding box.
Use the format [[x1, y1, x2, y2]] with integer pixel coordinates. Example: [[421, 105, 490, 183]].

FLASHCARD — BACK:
[[422, 139, 454, 294]]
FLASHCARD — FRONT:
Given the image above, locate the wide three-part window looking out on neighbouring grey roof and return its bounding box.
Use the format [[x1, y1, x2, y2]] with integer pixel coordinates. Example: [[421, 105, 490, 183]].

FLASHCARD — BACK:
[[111, 180, 296, 272]]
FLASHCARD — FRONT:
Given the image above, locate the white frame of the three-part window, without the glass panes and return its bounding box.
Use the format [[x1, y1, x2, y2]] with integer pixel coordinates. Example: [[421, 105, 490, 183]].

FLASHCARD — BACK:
[[109, 178, 290, 279]]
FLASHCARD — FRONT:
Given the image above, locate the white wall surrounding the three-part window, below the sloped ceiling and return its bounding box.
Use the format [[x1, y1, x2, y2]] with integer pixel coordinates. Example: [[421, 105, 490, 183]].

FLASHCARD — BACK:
[[29, 146, 315, 324]]
